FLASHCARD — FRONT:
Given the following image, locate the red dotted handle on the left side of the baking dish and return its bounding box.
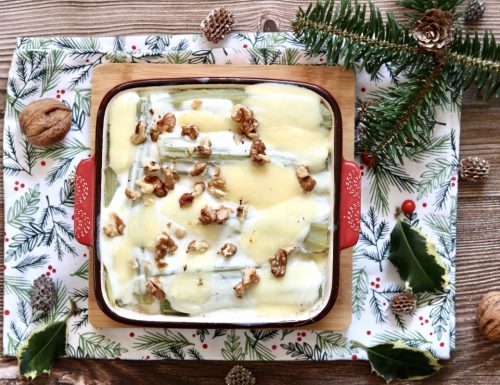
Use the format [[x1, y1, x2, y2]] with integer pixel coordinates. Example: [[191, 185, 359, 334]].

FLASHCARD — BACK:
[[74, 157, 95, 246]]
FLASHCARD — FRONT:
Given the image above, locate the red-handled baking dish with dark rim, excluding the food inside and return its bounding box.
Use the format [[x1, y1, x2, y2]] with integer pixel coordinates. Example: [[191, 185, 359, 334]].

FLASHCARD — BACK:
[[74, 77, 361, 328]]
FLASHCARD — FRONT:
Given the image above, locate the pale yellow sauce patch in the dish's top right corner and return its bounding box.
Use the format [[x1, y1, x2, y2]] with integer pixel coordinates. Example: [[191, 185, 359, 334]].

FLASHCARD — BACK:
[[243, 83, 322, 132]]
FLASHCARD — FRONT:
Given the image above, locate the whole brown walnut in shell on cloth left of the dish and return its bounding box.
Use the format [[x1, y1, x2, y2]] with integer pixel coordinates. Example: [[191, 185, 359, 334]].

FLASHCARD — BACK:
[[19, 99, 71, 147]]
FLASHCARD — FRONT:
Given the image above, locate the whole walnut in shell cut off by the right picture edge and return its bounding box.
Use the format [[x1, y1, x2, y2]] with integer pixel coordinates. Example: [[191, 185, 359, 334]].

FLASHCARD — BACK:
[[476, 291, 500, 341]]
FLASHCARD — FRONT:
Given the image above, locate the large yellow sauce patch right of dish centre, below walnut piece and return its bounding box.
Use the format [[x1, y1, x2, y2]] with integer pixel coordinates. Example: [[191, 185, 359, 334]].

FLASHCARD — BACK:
[[222, 160, 302, 208]]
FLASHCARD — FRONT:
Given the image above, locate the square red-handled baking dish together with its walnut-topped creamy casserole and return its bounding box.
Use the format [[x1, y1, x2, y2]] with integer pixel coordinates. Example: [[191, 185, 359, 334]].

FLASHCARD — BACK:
[[74, 78, 360, 328]]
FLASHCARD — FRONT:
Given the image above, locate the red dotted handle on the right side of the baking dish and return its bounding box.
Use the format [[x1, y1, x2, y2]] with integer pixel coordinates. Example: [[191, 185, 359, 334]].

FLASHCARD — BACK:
[[340, 159, 361, 249]]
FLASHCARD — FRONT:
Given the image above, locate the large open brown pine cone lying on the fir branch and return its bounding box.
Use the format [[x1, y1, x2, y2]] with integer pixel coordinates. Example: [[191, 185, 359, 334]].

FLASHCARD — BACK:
[[413, 8, 455, 51]]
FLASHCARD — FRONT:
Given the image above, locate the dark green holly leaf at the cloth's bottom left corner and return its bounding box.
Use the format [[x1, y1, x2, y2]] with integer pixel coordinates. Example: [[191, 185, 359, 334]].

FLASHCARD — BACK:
[[16, 320, 67, 381]]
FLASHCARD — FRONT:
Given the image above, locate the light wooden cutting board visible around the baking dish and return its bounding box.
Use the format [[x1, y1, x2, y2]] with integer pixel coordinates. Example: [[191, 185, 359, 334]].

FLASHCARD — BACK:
[[89, 64, 355, 330]]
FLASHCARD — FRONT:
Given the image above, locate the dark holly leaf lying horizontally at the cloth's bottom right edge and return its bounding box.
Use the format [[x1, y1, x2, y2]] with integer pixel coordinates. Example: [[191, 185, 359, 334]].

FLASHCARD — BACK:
[[357, 341, 441, 383]]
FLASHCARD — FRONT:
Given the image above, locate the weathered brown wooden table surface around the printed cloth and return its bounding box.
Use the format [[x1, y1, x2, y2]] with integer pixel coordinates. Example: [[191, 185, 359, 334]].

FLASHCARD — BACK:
[[0, 0, 500, 385]]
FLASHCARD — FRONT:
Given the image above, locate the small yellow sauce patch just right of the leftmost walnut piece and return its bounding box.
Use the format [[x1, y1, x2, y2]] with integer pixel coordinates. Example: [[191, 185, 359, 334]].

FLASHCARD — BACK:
[[126, 204, 161, 250]]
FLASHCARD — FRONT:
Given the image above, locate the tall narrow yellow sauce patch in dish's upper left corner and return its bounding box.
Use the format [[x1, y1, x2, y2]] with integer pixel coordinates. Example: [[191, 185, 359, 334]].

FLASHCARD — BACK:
[[108, 92, 139, 173]]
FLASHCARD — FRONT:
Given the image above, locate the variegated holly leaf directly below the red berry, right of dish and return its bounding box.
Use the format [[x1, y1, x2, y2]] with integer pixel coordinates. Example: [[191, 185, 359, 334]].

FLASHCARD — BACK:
[[389, 221, 449, 293]]
